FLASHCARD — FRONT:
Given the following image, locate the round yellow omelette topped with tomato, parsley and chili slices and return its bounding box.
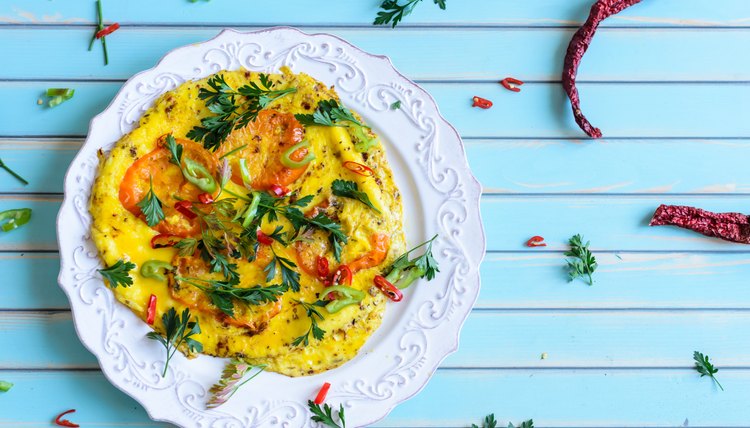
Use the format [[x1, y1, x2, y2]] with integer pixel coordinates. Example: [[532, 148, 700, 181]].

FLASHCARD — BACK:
[[90, 68, 405, 376]]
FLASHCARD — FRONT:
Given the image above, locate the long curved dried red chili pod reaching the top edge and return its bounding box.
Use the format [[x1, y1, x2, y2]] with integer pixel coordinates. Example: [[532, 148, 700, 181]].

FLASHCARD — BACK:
[[562, 0, 641, 138]]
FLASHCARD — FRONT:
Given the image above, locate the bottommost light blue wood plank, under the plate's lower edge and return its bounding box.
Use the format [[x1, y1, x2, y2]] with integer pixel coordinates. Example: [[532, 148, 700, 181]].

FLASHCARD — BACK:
[[0, 368, 750, 428]]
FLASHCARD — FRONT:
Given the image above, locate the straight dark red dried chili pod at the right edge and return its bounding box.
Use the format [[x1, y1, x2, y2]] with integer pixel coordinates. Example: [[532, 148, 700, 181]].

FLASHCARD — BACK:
[[649, 205, 750, 244]]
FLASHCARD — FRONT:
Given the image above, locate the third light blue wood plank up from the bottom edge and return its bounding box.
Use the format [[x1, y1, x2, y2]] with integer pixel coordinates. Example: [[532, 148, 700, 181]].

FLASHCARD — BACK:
[[7, 250, 750, 310]]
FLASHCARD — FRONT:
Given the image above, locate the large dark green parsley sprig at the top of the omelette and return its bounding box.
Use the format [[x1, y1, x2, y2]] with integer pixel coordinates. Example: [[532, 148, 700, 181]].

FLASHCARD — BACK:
[[187, 73, 297, 150]]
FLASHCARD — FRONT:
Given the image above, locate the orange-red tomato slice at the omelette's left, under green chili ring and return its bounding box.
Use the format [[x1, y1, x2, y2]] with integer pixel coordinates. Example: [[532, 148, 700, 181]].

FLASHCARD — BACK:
[[120, 136, 218, 237]]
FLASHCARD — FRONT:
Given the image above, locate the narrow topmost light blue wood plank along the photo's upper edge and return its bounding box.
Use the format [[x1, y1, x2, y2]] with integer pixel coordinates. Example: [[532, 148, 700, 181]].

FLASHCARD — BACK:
[[0, 0, 750, 26]]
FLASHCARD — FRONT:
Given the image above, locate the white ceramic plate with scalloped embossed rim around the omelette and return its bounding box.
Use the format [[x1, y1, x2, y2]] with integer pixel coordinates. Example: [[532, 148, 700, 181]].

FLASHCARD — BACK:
[[57, 28, 485, 428]]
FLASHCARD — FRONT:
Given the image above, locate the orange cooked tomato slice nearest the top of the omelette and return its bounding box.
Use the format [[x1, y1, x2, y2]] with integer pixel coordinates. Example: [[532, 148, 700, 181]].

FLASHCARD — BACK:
[[216, 110, 308, 190]]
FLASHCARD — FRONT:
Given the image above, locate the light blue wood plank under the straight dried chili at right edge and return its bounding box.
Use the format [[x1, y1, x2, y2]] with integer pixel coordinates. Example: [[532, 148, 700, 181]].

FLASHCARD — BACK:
[[10, 195, 750, 252]]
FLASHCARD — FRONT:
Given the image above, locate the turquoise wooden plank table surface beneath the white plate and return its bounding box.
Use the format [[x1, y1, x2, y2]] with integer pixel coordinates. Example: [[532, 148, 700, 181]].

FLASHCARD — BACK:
[[0, 0, 750, 427]]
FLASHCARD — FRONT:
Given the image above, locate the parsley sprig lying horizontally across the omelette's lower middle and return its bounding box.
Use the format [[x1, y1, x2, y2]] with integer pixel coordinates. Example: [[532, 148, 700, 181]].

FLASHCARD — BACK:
[[175, 274, 290, 318]]
